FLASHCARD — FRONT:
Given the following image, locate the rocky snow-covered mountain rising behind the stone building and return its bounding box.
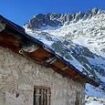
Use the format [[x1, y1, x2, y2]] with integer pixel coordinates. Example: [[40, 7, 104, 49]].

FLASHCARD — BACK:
[[24, 8, 105, 98]]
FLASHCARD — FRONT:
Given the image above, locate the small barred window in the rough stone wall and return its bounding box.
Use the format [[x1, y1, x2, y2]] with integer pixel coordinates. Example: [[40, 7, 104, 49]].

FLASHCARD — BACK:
[[33, 86, 51, 105]]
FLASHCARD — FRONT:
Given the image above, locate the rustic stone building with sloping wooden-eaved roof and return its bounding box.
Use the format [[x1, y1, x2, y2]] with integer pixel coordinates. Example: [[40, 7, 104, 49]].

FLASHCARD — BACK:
[[0, 16, 98, 105]]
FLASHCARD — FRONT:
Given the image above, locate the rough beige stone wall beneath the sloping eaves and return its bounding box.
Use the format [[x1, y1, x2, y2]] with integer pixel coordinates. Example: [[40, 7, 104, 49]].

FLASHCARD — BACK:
[[0, 47, 84, 105]]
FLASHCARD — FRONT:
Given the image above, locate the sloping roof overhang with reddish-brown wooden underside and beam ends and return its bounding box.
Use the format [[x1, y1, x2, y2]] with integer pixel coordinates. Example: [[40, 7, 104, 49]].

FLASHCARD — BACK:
[[0, 17, 99, 86]]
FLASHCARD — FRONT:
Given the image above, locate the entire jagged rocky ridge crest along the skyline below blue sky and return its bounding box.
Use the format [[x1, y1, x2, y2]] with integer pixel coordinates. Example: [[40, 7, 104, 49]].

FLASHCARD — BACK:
[[27, 9, 102, 30]]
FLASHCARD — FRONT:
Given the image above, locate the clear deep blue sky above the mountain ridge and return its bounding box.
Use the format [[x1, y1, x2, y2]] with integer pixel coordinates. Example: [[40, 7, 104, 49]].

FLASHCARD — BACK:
[[0, 0, 105, 25]]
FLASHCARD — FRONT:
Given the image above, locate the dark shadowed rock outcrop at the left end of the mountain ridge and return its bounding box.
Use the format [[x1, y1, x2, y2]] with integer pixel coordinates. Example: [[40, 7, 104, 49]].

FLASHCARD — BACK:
[[28, 14, 62, 29]]
